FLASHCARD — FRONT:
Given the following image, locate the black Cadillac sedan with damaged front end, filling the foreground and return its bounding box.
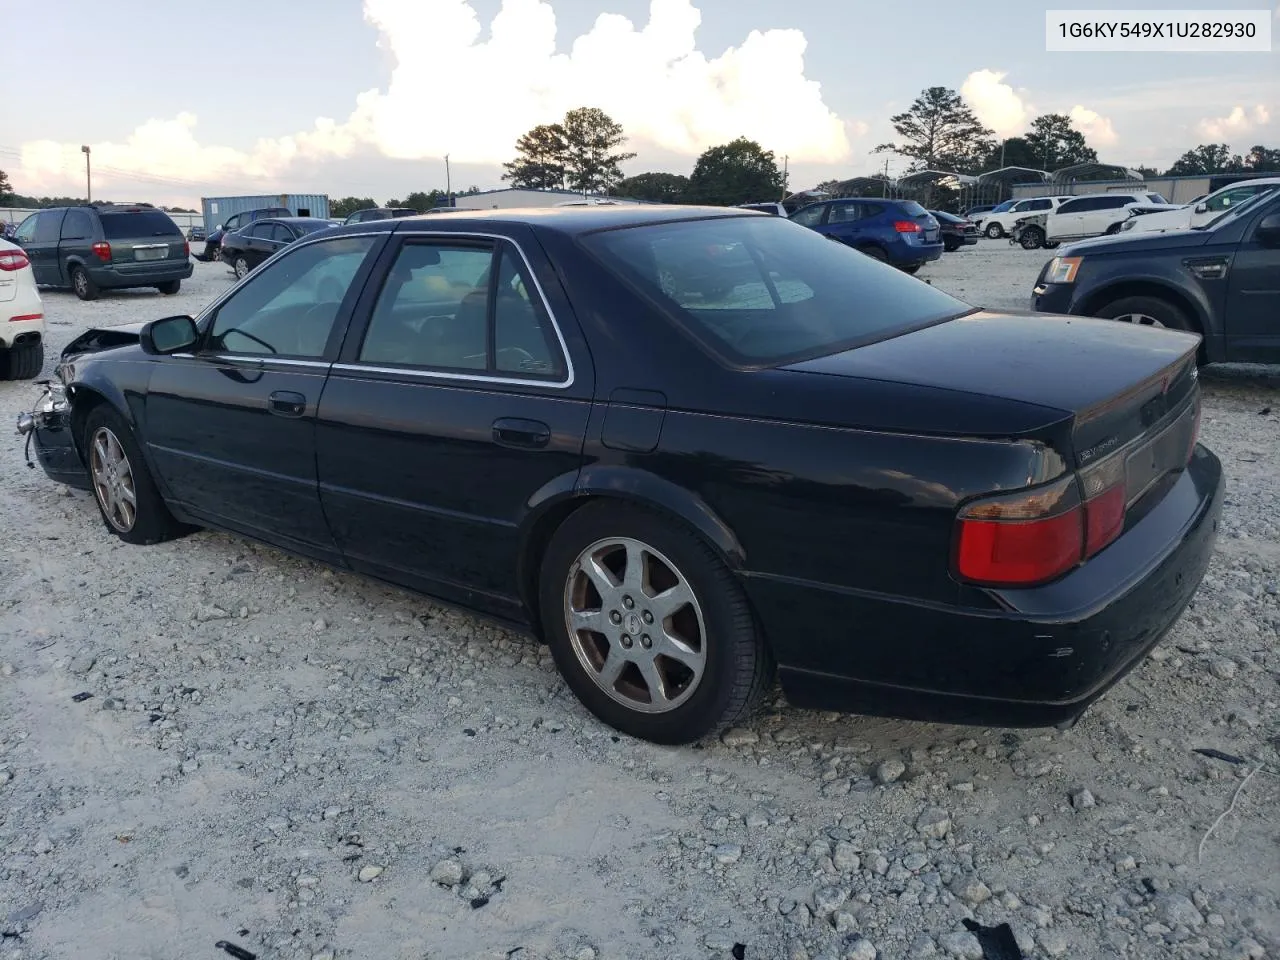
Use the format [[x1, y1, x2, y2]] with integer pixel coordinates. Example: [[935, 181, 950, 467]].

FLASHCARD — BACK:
[[19, 205, 1224, 742]]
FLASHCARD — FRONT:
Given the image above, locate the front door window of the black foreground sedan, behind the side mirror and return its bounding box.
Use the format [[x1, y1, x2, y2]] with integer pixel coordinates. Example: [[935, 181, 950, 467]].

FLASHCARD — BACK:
[[204, 237, 375, 360]]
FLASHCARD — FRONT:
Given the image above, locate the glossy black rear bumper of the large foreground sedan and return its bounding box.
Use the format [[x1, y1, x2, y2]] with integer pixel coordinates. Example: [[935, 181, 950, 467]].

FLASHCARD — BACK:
[[748, 447, 1225, 727]]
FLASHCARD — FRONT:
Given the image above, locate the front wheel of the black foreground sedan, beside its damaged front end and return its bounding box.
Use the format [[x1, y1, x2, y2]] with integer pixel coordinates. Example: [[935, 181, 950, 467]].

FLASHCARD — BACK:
[[82, 406, 184, 544]]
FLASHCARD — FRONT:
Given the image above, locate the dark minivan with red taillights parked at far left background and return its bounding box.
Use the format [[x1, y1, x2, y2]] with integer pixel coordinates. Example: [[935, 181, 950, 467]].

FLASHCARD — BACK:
[[15, 204, 195, 300]]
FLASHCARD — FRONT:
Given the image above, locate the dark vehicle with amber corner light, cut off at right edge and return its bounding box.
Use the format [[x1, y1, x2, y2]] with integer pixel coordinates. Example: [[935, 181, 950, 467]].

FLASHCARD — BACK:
[[1032, 191, 1280, 364]]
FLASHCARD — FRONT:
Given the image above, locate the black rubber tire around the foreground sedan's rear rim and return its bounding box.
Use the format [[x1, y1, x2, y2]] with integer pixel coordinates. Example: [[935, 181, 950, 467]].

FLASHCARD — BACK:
[[538, 500, 773, 744]]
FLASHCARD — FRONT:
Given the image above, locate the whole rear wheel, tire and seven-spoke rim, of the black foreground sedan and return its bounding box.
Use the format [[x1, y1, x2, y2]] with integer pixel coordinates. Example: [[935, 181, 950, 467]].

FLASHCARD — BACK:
[[539, 502, 773, 744]]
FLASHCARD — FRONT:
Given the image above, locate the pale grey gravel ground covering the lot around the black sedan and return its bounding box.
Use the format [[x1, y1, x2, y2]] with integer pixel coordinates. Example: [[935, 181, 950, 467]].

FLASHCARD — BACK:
[[0, 241, 1280, 960]]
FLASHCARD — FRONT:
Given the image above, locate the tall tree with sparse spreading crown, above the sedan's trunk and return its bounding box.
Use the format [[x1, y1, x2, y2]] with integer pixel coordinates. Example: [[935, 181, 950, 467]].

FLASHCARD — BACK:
[[876, 87, 995, 173]]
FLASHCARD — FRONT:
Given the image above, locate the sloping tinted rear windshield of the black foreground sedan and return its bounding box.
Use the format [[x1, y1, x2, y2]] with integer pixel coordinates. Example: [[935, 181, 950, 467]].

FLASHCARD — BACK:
[[582, 215, 970, 366]]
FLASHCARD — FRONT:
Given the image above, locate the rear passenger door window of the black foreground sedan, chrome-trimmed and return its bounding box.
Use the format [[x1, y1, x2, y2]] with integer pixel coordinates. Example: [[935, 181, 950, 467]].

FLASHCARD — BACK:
[[360, 239, 564, 379]]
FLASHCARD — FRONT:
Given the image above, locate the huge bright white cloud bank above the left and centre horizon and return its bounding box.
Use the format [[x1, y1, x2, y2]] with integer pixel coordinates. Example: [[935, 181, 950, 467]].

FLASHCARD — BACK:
[[22, 0, 849, 198]]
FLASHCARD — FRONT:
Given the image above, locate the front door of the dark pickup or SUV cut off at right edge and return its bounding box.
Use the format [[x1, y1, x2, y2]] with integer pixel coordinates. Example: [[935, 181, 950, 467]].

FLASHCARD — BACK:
[[1222, 200, 1280, 364]]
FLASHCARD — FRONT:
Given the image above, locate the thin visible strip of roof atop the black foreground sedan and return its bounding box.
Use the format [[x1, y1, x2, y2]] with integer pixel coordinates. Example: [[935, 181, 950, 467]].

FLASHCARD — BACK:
[[342, 204, 776, 236]]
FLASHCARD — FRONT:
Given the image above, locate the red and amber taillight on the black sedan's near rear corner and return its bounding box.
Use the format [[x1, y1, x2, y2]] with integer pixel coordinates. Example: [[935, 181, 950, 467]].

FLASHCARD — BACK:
[[956, 476, 1084, 586]]
